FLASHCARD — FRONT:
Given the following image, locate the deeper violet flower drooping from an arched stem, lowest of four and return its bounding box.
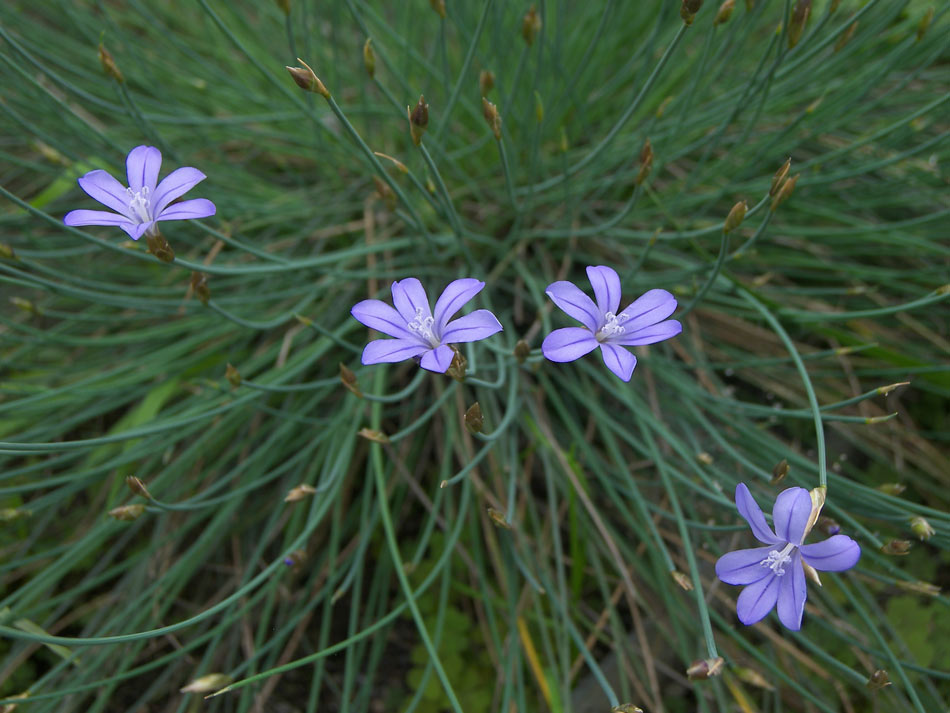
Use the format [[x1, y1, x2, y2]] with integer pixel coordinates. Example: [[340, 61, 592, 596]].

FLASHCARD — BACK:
[[716, 483, 861, 631]]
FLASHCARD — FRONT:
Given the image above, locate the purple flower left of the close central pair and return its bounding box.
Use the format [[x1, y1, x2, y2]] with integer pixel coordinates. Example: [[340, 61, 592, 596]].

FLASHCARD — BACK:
[[350, 277, 502, 374]]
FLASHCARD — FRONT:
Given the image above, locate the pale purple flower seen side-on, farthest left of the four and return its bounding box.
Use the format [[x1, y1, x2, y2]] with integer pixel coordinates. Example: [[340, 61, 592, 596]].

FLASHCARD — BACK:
[[63, 146, 215, 240]]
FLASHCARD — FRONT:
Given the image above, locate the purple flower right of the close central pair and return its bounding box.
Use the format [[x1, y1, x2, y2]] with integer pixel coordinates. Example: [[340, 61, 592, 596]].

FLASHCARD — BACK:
[[541, 265, 683, 381]]
